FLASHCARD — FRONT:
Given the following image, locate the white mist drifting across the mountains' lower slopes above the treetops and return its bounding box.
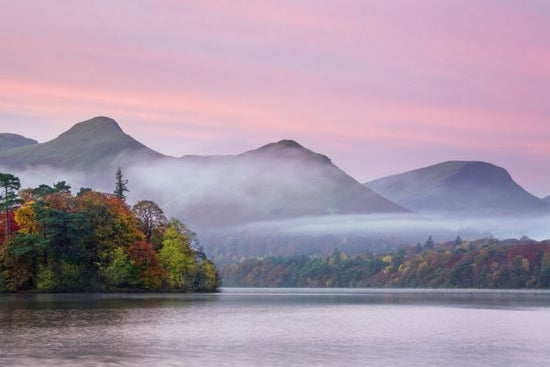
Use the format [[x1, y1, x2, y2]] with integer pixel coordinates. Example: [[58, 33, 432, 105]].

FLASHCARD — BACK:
[[5, 154, 550, 261]]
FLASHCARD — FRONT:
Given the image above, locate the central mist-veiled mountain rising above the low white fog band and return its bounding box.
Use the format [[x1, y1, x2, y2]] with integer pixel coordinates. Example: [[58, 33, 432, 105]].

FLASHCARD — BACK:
[[129, 140, 408, 226]]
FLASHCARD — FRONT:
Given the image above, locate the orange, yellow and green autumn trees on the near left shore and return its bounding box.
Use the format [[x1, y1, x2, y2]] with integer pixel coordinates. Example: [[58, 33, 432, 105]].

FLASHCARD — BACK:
[[0, 169, 219, 292]]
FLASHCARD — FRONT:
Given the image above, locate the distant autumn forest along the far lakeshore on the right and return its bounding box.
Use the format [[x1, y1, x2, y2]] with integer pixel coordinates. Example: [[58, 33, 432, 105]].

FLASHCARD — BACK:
[[221, 237, 550, 289]]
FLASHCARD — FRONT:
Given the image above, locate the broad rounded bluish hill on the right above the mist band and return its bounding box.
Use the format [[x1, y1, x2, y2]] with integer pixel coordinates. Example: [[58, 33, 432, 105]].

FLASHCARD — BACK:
[[365, 161, 550, 218]]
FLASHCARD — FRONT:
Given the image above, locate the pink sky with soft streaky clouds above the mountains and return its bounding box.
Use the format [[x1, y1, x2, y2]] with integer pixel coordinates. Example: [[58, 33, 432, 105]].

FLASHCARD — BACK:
[[0, 0, 550, 195]]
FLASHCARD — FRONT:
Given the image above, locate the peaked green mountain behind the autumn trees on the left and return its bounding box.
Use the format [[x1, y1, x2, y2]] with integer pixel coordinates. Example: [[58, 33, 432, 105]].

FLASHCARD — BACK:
[[0, 117, 162, 171]]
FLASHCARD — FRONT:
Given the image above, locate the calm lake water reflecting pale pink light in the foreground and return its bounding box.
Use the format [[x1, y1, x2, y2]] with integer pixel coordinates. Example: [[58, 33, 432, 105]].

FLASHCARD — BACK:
[[0, 289, 550, 367]]
